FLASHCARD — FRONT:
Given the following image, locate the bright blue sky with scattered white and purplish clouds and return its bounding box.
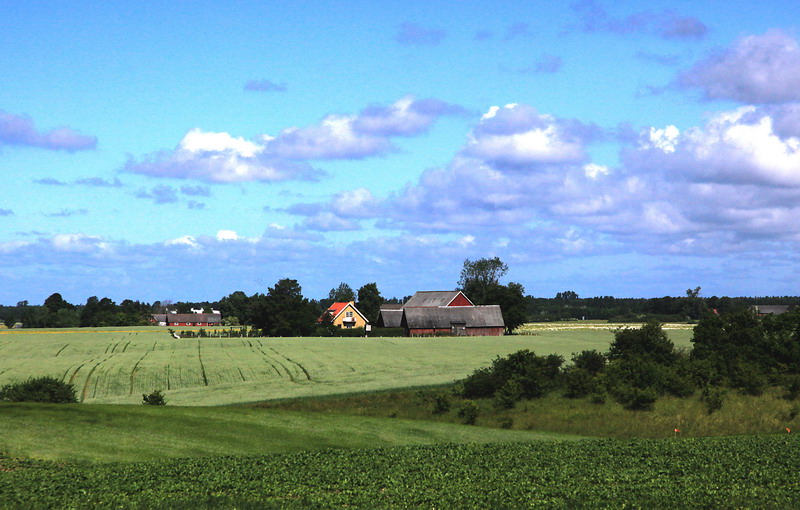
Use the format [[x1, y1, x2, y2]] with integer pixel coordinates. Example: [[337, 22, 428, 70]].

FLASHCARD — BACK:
[[0, 0, 800, 304]]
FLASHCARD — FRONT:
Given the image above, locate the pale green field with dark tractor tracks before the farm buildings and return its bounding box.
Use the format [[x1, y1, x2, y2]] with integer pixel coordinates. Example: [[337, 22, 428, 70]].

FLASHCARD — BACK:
[[0, 325, 691, 405]]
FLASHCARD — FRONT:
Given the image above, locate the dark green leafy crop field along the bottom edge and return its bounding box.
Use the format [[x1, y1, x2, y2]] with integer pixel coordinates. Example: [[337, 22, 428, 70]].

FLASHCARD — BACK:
[[0, 435, 800, 508]]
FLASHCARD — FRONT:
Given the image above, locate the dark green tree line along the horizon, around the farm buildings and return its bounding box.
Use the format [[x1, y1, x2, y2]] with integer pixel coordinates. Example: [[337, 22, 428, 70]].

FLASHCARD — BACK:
[[0, 257, 800, 336]]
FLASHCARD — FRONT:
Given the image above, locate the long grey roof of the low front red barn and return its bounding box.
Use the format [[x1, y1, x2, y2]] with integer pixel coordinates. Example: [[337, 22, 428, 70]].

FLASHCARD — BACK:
[[402, 305, 505, 329]]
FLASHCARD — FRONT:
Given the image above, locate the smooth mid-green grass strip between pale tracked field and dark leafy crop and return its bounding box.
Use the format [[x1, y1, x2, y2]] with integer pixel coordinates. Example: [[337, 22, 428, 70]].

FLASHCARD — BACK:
[[0, 403, 578, 462]]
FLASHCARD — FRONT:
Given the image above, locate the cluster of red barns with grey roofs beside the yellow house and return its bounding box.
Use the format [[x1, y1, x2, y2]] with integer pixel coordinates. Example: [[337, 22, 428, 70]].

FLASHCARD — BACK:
[[378, 290, 505, 336]]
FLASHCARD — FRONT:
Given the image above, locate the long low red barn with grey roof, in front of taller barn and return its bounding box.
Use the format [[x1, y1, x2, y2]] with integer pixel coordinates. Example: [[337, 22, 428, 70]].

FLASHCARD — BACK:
[[401, 305, 505, 336]]
